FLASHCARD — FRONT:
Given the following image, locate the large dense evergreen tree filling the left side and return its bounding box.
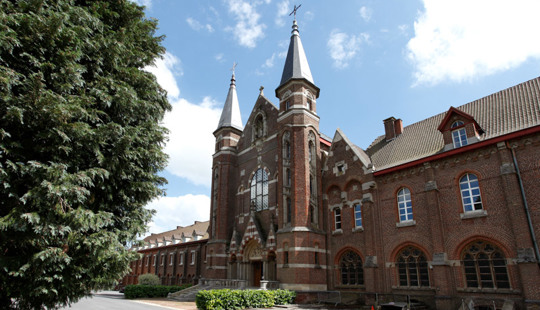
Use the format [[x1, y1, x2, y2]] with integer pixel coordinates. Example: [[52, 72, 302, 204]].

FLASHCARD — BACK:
[[0, 0, 170, 309]]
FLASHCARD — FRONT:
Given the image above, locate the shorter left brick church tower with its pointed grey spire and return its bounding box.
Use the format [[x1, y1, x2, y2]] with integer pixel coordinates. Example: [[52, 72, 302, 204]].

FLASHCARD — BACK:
[[205, 70, 244, 279]]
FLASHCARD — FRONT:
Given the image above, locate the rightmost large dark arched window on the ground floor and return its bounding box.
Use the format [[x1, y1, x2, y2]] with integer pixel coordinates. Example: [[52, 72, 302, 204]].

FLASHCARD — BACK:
[[462, 241, 510, 288]]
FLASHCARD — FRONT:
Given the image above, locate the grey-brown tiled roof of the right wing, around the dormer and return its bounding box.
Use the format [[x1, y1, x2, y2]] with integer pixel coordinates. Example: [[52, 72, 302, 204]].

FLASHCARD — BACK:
[[366, 77, 540, 171]]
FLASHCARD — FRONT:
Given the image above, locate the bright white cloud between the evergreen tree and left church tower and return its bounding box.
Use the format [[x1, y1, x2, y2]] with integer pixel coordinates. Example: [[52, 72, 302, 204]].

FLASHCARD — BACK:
[[164, 96, 225, 187]]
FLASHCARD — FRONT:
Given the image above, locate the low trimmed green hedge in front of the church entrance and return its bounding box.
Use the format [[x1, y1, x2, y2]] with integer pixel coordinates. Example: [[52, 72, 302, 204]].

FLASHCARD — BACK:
[[195, 289, 296, 310]]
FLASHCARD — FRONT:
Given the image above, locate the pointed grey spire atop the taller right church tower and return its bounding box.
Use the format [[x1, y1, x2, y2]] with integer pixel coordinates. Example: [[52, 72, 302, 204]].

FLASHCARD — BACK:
[[278, 18, 315, 88]]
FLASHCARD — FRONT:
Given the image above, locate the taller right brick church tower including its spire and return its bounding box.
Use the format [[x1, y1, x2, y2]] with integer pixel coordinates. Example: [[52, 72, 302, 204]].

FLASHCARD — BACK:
[[276, 15, 327, 291]]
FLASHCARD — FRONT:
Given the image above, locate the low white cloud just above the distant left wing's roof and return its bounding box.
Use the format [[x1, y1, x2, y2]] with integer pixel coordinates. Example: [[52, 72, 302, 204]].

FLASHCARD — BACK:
[[146, 194, 210, 235]]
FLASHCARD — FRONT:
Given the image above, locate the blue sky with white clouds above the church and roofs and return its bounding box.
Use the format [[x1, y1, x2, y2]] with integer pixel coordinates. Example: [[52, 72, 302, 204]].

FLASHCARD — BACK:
[[137, 0, 540, 232]]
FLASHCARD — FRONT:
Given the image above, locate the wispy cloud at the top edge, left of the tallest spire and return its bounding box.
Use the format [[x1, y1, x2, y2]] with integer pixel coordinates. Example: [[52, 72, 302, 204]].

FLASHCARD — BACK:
[[226, 0, 266, 48]]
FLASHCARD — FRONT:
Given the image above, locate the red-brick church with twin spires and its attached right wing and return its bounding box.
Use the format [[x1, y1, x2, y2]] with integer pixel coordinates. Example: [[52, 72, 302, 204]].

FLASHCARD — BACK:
[[124, 20, 540, 309]]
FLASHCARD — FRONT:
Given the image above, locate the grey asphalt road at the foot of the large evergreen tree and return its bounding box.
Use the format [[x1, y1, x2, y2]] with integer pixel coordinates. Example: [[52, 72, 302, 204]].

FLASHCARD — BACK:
[[62, 291, 173, 310]]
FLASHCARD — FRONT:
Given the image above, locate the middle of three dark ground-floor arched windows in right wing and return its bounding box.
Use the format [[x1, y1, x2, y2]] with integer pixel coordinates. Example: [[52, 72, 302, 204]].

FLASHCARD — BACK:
[[397, 246, 429, 287]]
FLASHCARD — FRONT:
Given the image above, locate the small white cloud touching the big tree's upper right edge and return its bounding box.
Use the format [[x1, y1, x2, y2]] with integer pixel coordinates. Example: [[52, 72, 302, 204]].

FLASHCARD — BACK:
[[144, 52, 182, 98]]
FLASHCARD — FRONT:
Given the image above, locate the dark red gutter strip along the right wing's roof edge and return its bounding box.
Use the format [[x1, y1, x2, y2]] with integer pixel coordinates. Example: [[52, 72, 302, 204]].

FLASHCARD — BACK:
[[373, 125, 540, 177]]
